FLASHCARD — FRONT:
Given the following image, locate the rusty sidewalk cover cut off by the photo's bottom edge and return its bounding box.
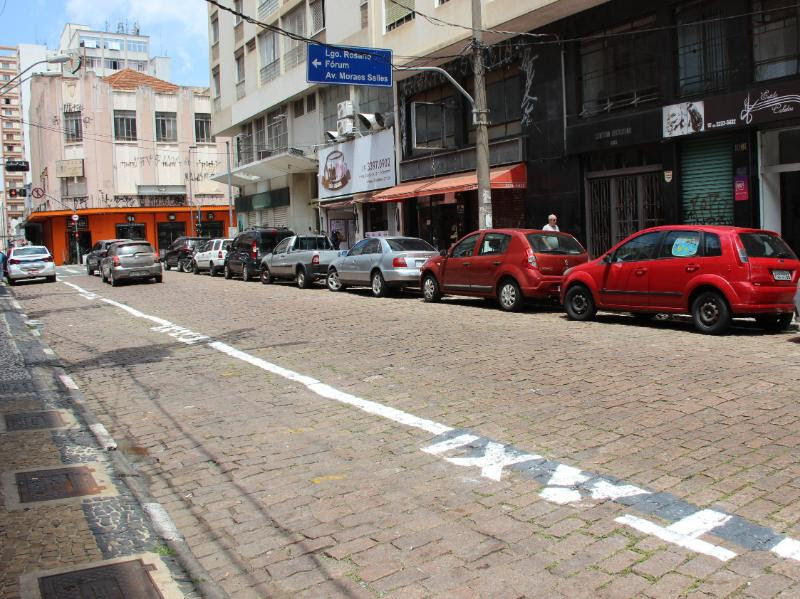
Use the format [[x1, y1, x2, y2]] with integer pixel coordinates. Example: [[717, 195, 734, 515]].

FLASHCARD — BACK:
[[39, 560, 163, 599]]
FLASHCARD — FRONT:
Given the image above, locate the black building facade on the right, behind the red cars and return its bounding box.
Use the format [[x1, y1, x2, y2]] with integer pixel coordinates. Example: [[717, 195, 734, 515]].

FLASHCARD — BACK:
[[398, 0, 800, 255]]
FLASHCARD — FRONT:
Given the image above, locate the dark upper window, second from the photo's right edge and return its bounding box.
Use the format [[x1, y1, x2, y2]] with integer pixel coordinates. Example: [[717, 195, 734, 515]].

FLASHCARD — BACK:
[[676, 0, 731, 95]]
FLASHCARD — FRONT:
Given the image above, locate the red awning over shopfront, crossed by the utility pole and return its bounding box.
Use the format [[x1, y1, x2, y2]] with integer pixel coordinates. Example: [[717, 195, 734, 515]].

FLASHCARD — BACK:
[[370, 163, 528, 202]]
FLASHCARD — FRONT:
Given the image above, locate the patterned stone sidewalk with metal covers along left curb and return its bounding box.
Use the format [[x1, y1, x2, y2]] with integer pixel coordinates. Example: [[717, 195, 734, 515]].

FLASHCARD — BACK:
[[0, 284, 212, 599]]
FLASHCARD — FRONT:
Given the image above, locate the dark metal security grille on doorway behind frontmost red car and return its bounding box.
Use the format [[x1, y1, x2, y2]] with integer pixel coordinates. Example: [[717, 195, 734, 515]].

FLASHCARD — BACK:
[[586, 166, 663, 256]]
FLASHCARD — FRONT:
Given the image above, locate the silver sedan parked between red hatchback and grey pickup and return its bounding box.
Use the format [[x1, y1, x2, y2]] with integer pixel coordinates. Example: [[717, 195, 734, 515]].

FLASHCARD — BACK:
[[326, 237, 438, 297]]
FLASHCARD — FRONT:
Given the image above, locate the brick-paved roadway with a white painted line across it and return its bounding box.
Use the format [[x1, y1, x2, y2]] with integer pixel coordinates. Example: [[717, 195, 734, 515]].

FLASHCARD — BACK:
[[9, 273, 800, 597]]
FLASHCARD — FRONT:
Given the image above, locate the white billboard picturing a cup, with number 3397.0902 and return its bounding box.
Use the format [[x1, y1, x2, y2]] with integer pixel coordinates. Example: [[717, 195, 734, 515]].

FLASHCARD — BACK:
[[318, 129, 397, 199]]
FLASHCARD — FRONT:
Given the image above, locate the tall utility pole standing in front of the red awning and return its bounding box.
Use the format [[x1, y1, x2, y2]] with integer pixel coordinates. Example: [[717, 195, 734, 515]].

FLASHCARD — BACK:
[[472, 0, 492, 229]]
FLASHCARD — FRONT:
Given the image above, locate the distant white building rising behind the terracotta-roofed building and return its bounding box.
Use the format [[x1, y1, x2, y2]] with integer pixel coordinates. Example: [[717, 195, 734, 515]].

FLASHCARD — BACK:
[[59, 23, 171, 81]]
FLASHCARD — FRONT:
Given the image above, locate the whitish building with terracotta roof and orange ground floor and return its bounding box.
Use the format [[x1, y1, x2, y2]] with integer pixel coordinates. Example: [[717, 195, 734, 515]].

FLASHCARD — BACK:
[[25, 69, 230, 264]]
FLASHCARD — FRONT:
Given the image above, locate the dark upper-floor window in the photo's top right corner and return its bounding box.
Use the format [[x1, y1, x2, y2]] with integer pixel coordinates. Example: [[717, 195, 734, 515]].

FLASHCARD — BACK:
[[753, 0, 800, 81]]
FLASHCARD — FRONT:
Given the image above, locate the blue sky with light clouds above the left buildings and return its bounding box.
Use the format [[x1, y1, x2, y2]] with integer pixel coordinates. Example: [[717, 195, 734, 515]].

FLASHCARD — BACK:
[[0, 0, 209, 87]]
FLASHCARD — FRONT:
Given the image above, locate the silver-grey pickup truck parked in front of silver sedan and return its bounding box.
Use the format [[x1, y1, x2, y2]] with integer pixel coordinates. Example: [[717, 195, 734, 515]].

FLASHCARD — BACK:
[[261, 235, 339, 289]]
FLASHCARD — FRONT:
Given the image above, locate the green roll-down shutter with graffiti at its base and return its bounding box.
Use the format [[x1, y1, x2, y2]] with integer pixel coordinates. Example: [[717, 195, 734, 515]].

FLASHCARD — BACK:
[[680, 135, 735, 225]]
